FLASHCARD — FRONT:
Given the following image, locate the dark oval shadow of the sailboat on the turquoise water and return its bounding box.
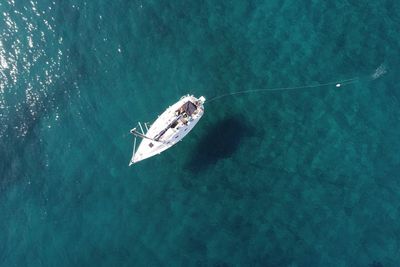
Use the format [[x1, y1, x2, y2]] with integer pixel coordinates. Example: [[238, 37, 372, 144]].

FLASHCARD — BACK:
[[184, 116, 253, 172]]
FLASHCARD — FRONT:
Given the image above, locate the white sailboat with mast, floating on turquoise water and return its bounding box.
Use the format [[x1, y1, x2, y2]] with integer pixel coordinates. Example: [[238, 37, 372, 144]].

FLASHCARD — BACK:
[[129, 95, 206, 166]]
